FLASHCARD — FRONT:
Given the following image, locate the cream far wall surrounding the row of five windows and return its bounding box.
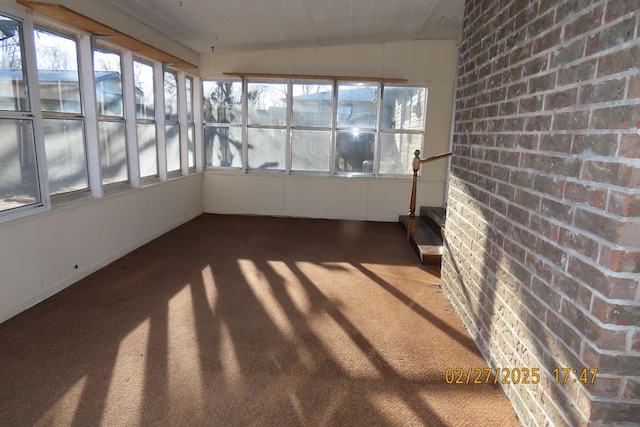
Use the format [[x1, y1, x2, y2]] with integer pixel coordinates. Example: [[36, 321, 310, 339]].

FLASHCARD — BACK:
[[200, 40, 457, 221]]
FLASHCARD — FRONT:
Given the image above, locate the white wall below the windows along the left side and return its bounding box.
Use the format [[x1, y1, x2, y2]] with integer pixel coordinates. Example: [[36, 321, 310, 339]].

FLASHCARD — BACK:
[[0, 174, 202, 322]]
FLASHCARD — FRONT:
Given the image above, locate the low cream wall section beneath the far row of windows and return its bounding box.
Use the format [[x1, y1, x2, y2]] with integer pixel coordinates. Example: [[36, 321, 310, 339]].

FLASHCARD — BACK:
[[203, 173, 443, 221]]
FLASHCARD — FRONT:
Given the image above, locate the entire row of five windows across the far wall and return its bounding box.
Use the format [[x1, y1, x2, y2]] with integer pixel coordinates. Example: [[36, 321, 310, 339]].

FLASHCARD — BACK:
[[203, 79, 427, 177]]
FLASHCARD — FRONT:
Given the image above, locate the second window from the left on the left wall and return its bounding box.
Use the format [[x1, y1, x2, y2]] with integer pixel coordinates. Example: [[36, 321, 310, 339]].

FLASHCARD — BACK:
[[34, 29, 89, 195]]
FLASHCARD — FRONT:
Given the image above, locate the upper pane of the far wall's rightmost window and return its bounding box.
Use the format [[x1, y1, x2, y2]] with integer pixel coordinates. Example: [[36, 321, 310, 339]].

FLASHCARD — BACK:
[[382, 87, 427, 130]]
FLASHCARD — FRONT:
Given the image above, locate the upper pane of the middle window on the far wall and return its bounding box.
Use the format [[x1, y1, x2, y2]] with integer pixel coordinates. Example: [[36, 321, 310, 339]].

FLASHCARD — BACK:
[[292, 83, 333, 127]]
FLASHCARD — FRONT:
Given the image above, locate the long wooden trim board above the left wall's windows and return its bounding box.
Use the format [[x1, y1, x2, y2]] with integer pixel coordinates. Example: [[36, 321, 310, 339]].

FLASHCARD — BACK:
[[16, 0, 198, 69]]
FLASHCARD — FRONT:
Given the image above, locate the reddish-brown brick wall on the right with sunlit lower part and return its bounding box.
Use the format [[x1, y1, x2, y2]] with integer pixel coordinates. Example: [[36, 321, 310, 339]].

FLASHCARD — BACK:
[[442, 0, 640, 426]]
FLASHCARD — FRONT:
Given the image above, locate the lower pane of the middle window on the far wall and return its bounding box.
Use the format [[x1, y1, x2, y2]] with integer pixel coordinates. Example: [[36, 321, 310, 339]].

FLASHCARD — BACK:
[[291, 130, 331, 171]]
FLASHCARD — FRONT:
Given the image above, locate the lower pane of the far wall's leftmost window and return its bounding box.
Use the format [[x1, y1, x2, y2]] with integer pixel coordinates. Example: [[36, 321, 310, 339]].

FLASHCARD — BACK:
[[204, 126, 242, 168]]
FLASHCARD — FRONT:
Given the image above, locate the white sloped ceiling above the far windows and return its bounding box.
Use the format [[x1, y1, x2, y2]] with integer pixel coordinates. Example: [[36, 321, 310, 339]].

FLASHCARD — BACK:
[[97, 0, 464, 53]]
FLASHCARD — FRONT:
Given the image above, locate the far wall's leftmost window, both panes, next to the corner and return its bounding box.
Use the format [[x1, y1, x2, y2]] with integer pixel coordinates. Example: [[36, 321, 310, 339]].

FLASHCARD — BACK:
[[202, 81, 242, 168]]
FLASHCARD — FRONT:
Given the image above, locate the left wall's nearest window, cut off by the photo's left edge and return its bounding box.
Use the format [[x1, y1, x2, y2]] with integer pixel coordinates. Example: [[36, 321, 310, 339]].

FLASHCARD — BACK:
[[0, 15, 42, 216]]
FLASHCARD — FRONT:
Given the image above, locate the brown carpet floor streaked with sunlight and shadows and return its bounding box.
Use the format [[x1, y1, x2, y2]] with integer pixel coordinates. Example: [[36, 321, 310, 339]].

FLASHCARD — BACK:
[[0, 215, 519, 426]]
